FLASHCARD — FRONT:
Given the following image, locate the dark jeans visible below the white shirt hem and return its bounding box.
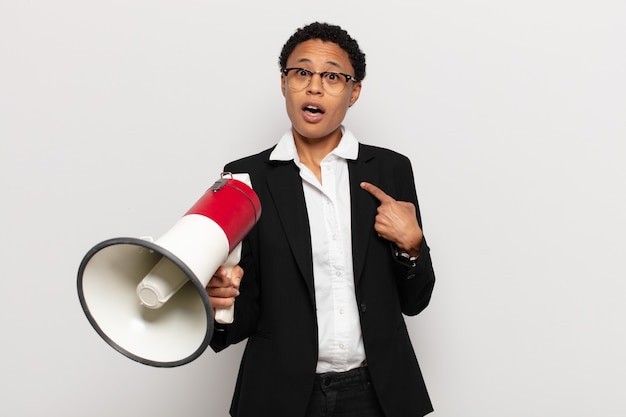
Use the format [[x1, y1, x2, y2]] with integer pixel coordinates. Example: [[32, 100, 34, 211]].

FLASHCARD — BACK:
[[306, 366, 385, 417]]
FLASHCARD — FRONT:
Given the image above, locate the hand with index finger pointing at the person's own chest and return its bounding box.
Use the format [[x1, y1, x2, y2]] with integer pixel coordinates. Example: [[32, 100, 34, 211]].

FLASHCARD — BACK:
[[361, 182, 423, 256]]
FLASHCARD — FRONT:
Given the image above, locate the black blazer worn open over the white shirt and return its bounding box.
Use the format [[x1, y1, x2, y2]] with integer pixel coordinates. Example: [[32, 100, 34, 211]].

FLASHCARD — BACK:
[[211, 144, 435, 417]]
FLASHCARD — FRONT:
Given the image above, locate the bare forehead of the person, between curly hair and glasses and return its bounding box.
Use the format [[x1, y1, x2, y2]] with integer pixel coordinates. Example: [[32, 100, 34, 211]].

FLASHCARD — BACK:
[[287, 39, 353, 72]]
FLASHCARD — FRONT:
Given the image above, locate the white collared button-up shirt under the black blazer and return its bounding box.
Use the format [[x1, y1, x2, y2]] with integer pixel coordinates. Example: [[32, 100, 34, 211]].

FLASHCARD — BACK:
[[270, 127, 365, 373]]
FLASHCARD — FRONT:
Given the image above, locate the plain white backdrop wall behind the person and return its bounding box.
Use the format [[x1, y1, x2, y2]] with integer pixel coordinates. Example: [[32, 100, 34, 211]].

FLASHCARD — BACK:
[[0, 0, 626, 417]]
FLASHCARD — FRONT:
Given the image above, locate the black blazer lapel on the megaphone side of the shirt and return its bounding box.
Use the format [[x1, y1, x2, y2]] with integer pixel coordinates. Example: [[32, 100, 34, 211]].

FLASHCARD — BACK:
[[267, 161, 315, 305]]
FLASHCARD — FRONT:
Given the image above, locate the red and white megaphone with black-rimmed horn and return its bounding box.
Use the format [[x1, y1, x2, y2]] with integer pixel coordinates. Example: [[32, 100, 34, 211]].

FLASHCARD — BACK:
[[78, 173, 261, 367]]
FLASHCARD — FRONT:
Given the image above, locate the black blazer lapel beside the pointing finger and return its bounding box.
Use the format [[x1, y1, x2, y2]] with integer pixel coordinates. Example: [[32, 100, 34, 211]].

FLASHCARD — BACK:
[[348, 145, 378, 284]]
